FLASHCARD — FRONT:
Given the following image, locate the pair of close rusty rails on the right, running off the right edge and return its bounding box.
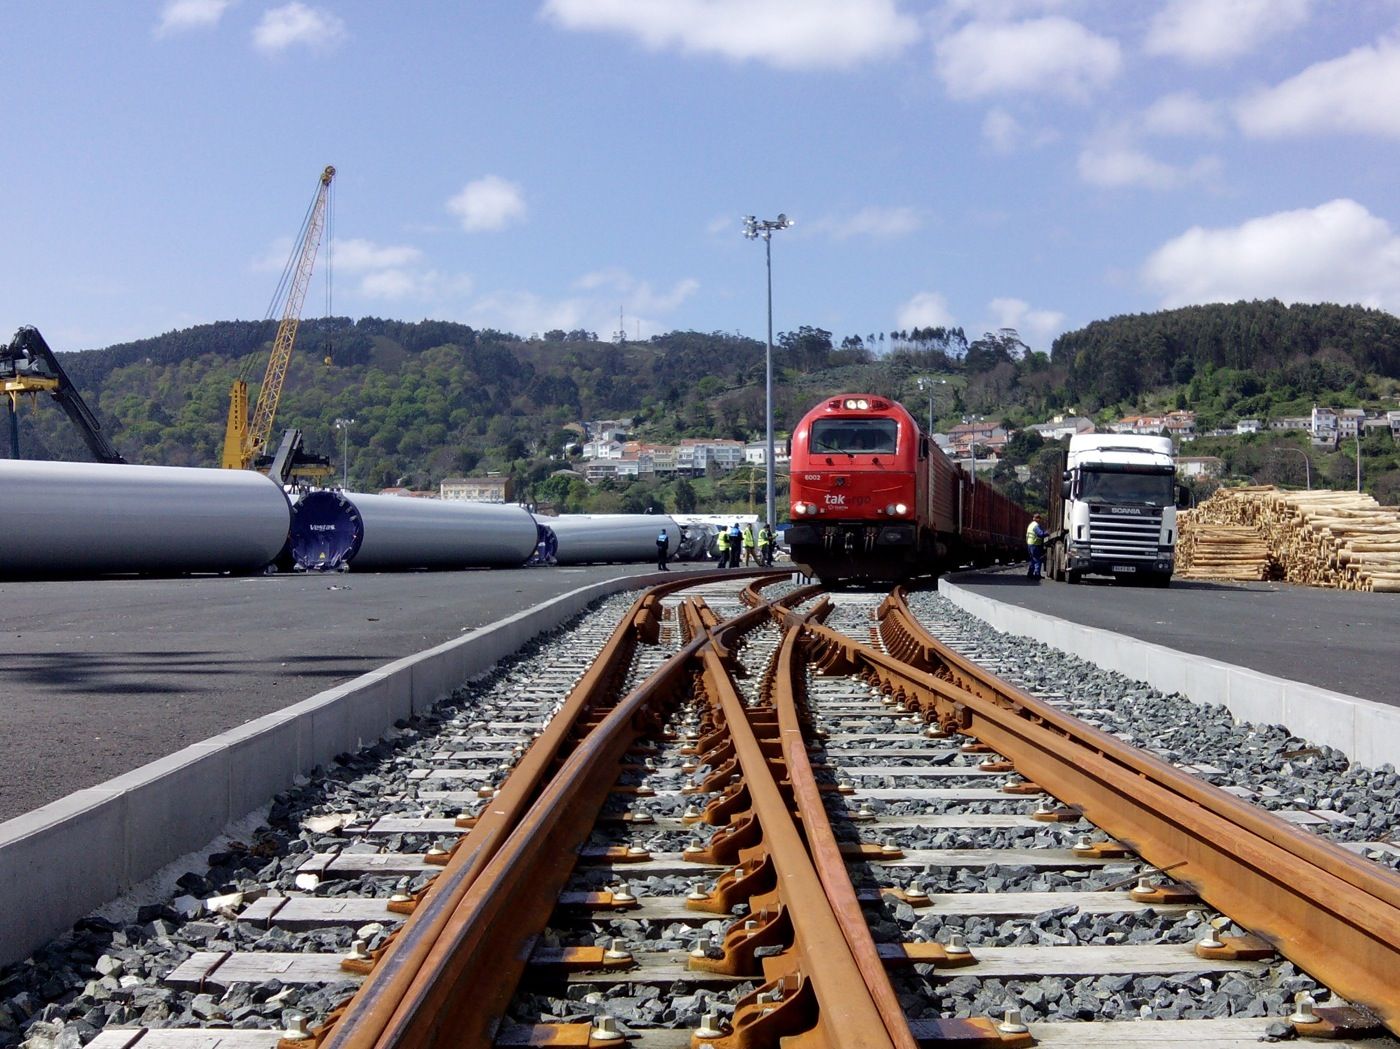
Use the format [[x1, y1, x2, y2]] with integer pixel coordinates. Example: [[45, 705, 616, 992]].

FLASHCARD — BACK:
[[804, 591, 1400, 1034]]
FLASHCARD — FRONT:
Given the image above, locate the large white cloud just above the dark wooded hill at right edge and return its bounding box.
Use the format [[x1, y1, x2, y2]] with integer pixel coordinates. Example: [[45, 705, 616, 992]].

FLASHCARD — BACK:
[[1142, 199, 1400, 312]]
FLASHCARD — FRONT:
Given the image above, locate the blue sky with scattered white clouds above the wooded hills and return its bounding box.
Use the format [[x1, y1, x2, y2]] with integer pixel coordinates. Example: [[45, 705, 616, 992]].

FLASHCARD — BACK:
[[8, 0, 1400, 350]]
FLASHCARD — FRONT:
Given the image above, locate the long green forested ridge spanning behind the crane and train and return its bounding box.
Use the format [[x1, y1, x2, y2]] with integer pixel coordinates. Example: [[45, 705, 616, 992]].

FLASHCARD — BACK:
[[10, 301, 1400, 487]]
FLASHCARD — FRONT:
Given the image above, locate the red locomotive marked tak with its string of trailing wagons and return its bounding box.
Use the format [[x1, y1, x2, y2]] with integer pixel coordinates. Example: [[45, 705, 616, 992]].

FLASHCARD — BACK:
[[787, 394, 1030, 583]]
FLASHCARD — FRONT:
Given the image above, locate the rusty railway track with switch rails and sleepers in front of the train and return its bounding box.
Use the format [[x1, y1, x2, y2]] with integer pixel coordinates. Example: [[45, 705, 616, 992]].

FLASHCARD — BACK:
[[13, 578, 1400, 1049]]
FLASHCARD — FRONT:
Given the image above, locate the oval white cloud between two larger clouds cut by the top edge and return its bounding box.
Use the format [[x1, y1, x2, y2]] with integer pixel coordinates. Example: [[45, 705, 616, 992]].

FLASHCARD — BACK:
[[935, 15, 1123, 99]]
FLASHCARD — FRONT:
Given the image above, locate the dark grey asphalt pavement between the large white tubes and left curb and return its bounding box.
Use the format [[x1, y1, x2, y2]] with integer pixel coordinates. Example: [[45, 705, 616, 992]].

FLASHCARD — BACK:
[[0, 564, 669, 821]]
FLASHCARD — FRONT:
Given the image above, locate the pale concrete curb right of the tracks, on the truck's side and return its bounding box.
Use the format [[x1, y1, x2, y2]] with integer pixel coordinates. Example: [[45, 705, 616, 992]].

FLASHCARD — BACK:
[[938, 578, 1400, 767]]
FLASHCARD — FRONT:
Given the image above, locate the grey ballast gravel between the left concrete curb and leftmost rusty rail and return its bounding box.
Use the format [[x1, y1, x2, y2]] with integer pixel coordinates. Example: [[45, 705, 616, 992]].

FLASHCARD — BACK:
[[0, 595, 633, 1049]]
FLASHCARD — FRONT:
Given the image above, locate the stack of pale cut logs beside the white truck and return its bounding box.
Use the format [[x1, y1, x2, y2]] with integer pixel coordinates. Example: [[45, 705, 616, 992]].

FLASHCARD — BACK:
[[1182, 485, 1400, 592]]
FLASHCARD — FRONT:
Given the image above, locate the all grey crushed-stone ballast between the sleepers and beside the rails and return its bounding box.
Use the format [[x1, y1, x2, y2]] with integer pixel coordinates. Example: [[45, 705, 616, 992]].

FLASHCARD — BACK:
[[0, 591, 1400, 1049]]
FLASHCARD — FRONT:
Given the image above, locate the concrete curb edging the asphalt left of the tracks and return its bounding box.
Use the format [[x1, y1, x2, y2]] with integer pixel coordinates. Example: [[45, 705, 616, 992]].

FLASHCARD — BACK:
[[0, 573, 675, 965]]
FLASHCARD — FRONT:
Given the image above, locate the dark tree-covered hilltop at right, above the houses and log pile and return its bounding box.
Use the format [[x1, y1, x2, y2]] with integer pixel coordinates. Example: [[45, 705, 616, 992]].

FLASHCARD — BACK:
[[1050, 298, 1400, 408]]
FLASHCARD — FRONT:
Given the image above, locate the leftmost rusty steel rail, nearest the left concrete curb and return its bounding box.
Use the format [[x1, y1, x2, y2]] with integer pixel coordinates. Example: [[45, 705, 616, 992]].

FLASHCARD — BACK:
[[315, 578, 711, 1049]]
